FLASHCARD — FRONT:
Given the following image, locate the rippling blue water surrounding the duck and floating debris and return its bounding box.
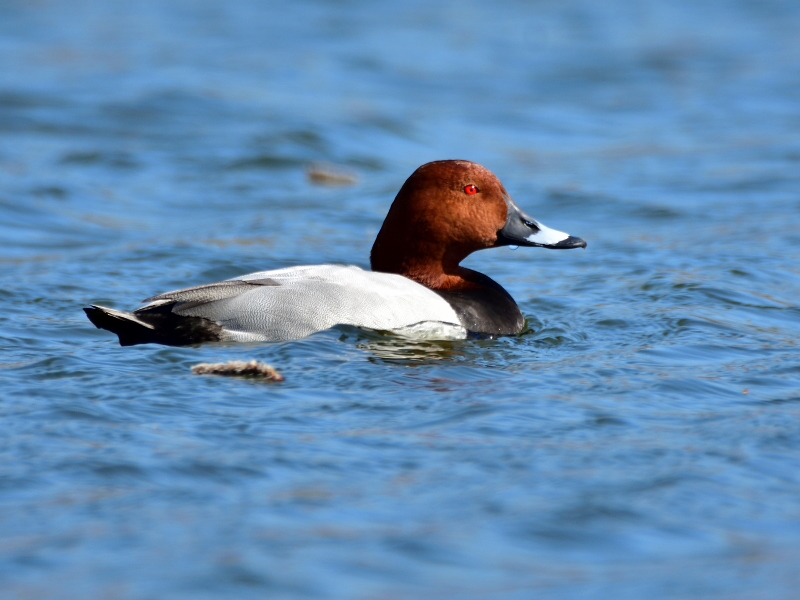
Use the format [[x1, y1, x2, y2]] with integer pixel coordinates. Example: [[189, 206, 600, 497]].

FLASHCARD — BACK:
[[0, 0, 800, 599]]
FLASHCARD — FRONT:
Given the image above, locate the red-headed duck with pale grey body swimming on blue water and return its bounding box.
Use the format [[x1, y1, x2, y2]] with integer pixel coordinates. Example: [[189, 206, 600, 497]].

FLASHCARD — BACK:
[[83, 160, 586, 346]]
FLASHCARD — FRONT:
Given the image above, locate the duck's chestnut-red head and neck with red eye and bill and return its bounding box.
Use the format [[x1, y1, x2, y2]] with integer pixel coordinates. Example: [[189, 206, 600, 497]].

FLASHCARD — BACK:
[[370, 160, 586, 289]]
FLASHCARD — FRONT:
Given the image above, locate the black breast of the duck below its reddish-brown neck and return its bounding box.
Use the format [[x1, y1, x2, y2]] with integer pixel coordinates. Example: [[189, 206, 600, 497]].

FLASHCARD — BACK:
[[434, 271, 525, 337]]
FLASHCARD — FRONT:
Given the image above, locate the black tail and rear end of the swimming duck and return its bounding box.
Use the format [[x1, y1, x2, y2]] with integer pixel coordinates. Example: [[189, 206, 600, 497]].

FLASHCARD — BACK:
[[83, 305, 223, 346]]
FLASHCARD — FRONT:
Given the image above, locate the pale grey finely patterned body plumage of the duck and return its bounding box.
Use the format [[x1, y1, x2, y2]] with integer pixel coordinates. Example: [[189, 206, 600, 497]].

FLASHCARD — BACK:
[[135, 265, 466, 341]]
